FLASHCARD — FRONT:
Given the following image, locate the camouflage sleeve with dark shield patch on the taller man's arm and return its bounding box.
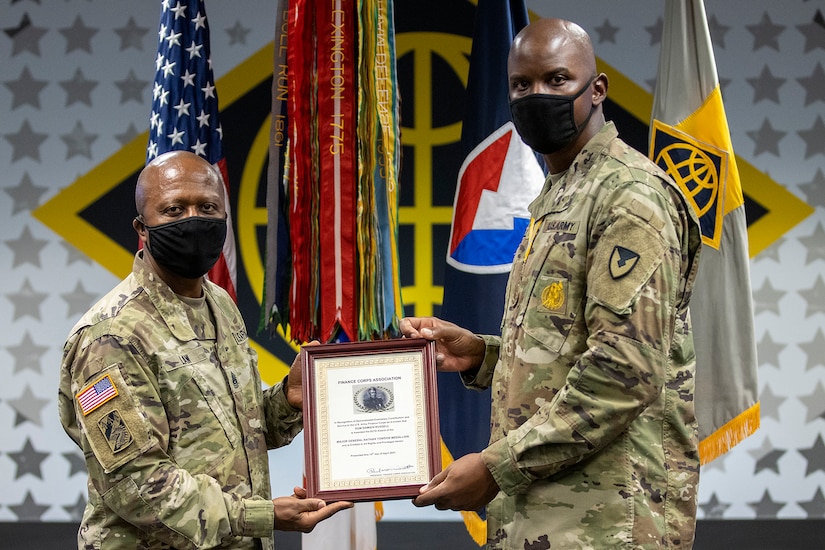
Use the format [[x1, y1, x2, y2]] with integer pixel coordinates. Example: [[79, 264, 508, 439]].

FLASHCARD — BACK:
[[482, 184, 681, 495]]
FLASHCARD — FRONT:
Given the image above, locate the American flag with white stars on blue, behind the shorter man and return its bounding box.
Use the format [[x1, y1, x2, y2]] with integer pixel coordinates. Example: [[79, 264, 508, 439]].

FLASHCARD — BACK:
[[146, 0, 237, 299]]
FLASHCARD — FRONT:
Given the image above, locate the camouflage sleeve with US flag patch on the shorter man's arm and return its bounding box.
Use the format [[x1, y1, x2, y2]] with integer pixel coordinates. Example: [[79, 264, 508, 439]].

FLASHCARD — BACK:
[[70, 335, 274, 549]]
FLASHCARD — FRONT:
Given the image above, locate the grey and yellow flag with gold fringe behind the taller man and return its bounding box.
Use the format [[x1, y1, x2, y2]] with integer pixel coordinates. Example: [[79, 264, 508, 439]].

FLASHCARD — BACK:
[[650, 0, 759, 464]]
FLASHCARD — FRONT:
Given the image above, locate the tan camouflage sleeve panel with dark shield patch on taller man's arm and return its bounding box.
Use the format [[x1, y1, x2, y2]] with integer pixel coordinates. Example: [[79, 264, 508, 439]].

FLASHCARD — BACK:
[[588, 216, 665, 315]]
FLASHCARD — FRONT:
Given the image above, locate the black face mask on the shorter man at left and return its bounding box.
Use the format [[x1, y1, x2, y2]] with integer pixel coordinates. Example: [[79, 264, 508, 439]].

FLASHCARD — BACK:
[[138, 216, 226, 279]]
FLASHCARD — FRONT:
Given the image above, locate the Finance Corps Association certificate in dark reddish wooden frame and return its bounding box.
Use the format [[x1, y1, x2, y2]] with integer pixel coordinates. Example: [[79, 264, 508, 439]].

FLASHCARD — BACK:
[[301, 338, 441, 501]]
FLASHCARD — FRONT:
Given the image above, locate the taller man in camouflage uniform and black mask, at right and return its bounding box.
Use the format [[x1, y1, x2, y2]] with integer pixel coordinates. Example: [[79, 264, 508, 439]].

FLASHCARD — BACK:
[[401, 19, 700, 550]]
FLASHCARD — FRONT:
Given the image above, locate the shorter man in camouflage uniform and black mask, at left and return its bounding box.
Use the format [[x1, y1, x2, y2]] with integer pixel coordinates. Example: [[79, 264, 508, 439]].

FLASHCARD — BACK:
[[59, 151, 350, 550]]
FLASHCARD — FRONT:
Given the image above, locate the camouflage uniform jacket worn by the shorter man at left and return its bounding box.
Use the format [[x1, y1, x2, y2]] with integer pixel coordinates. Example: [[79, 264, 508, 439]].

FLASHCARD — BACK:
[[59, 253, 302, 550]]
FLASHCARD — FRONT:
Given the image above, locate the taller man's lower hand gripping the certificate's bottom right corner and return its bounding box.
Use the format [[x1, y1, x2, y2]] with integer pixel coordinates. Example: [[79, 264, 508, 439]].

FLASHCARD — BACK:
[[413, 453, 499, 511]]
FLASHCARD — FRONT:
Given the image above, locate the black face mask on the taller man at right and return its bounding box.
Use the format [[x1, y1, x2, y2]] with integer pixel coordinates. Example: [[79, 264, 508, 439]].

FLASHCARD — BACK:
[[510, 77, 595, 155]]
